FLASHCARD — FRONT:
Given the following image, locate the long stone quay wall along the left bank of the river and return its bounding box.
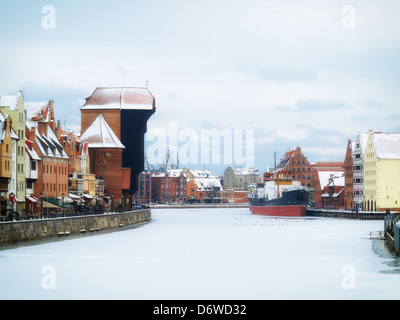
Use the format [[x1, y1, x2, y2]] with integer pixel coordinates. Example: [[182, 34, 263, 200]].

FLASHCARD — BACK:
[[0, 209, 151, 245]]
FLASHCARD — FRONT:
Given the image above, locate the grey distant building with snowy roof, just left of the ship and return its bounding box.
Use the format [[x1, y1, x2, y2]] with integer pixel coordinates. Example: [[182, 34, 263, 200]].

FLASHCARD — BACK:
[[223, 167, 260, 190]]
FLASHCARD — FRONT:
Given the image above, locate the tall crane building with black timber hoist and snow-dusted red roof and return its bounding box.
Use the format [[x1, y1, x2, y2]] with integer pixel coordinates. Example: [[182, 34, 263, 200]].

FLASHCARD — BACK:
[[81, 87, 155, 196]]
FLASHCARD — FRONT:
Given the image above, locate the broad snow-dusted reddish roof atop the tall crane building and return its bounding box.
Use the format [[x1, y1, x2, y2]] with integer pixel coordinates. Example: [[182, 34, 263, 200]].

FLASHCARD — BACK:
[[81, 87, 155, 110]]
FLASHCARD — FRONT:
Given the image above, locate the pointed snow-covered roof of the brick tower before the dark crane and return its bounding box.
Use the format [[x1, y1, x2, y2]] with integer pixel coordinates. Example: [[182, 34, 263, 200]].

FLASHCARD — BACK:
[[81, 115, 125, 149]]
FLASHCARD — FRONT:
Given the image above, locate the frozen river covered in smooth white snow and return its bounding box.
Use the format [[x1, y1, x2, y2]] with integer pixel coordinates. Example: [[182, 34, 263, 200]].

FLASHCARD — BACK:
[[0, 209, 400, 300]]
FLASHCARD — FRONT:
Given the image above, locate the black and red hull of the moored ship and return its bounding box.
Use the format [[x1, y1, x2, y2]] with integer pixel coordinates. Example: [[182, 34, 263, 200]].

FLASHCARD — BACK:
[[249, 189, 308, 217]]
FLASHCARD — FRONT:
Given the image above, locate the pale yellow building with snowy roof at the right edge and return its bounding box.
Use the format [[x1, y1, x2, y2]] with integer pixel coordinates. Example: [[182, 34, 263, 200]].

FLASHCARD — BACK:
[[364, 131, 400, 211]]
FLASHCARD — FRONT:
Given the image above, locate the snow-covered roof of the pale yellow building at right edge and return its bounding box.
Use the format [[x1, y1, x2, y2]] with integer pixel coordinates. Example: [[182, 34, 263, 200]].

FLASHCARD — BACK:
[[373, 132, 400, 159]]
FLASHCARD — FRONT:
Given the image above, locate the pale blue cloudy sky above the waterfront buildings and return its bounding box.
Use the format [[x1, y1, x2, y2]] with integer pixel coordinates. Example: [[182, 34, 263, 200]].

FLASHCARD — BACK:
[[0, 0, 400, 173]]
